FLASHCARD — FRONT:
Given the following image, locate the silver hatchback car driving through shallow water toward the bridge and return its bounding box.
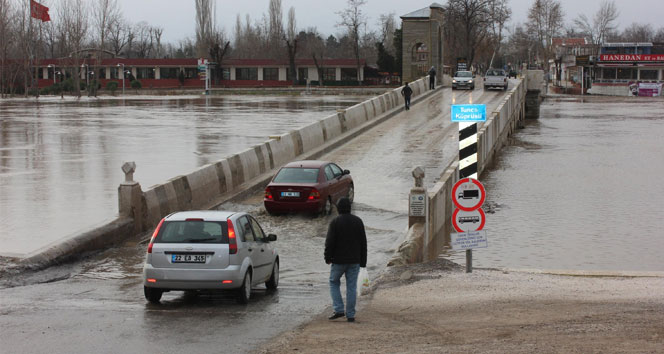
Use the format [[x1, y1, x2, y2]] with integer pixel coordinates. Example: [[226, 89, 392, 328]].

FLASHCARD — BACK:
[[143, 210, 279, 303]]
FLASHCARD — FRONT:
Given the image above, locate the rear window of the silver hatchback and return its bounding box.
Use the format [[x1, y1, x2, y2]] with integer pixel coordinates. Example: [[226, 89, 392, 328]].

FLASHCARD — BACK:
[[155, 220, 228, 243]]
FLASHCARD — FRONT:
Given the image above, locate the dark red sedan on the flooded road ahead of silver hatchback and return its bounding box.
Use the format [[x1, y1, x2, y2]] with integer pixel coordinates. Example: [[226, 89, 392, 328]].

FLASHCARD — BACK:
[[263, 161, 355, 215]]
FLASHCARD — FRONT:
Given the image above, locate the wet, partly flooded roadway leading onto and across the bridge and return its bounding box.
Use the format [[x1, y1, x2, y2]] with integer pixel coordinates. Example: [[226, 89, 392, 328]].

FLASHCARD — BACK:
[[0, 85, 503, 353]]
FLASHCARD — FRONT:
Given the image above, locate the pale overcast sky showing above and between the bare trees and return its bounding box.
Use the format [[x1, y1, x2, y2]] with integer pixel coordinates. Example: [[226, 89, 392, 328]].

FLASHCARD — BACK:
[[118, 0, 664, 42]]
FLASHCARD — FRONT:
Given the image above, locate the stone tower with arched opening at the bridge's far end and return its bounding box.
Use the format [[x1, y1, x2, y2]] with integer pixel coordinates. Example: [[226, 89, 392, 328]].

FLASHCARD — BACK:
[[401, 2, 444, 82]]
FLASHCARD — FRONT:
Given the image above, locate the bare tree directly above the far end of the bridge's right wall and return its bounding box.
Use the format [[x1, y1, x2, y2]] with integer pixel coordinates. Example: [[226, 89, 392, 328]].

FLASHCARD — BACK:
[[527, 0, 564, 61]]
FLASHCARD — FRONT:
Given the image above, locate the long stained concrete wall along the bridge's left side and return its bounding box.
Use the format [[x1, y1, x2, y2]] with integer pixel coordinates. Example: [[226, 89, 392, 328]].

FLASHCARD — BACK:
[[143, 78, 428, 230]]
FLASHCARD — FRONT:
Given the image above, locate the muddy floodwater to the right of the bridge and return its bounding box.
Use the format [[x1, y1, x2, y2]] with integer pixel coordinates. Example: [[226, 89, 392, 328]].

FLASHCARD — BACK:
[[453, 98, 664, 271]]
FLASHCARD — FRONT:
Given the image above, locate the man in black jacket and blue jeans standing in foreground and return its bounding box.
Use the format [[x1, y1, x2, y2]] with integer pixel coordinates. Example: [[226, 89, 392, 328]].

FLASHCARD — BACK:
[[325, 198, 368, 322]]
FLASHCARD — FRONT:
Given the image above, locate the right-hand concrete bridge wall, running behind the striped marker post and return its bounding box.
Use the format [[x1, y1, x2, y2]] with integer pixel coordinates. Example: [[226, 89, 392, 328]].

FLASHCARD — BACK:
[[390, 80, 527, 265]]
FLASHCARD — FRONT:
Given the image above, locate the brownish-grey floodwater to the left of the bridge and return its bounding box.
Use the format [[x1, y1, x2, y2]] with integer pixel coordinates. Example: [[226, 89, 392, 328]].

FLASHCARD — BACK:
[[0, 96, 366, 255]]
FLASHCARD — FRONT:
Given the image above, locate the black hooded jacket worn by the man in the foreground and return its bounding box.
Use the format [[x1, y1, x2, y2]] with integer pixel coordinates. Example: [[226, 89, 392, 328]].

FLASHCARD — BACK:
[[325, 214, 367, 267]]
